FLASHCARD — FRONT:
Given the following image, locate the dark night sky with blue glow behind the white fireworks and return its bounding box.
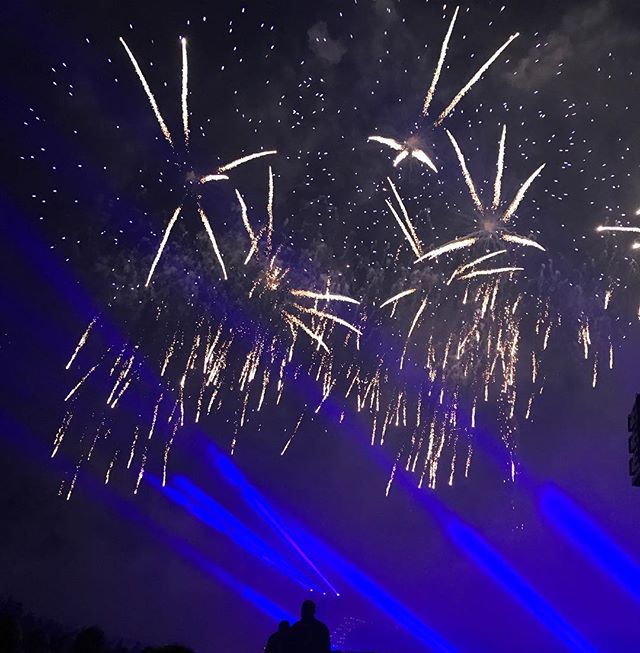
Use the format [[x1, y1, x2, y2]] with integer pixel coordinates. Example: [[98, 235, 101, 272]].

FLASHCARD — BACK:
[[0, 0, 640, 653]]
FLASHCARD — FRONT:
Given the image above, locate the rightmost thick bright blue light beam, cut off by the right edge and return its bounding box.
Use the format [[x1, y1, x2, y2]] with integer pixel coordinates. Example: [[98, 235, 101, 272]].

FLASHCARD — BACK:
[[540, 486, 640, 601]]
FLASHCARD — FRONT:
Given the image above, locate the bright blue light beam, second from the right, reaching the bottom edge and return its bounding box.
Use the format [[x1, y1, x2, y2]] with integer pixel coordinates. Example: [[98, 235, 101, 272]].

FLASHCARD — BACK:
[[446, 518, 595, 653]]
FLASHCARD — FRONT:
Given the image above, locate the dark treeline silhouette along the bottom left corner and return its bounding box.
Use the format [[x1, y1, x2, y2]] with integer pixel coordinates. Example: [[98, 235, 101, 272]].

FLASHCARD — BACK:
[[0, 600, 193, 653]]
